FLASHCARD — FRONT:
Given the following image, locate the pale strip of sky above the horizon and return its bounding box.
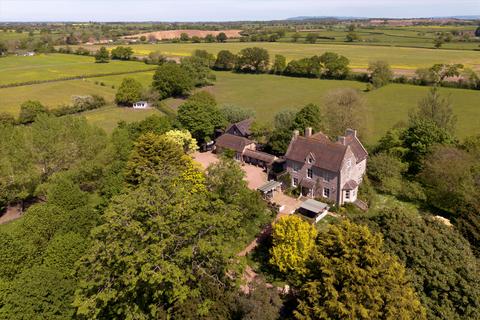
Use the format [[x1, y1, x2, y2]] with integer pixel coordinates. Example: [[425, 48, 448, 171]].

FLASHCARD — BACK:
[[0, 0, 480, 21]]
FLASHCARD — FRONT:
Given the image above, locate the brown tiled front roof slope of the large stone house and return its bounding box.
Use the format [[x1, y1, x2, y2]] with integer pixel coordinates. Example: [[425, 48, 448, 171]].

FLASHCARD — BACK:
[[285, 134, 349, 172]]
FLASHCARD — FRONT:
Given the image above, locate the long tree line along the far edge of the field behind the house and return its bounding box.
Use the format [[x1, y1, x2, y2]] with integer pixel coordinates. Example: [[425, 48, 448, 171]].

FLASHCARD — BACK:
[[175, 48, 480, 90]]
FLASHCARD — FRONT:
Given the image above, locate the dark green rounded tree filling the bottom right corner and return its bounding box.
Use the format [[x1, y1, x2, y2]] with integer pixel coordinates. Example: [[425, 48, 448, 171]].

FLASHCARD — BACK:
[[364, 208, 480, 319]]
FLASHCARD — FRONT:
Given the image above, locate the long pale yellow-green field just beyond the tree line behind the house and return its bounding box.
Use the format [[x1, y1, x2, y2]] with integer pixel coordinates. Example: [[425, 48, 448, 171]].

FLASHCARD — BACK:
[[77, 39, 480, 70]]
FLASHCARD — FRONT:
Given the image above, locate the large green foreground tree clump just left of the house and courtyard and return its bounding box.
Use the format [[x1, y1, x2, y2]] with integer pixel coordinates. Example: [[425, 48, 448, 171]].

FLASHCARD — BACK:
[[74, 127, 278, 319]]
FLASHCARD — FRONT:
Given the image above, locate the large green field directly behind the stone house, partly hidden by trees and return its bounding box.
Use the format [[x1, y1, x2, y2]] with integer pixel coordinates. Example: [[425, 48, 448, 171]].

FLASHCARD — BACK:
[[206, 72, 480, 143]]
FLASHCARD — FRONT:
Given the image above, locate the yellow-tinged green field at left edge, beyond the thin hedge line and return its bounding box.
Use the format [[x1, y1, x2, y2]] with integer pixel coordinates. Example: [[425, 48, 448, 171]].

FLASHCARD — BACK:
[[0, 54, 152, 84]]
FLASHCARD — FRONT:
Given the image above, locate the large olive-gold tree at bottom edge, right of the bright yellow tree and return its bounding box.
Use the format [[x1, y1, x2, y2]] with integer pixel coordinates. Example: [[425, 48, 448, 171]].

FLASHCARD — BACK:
[[294, 221, 426, 319]]
